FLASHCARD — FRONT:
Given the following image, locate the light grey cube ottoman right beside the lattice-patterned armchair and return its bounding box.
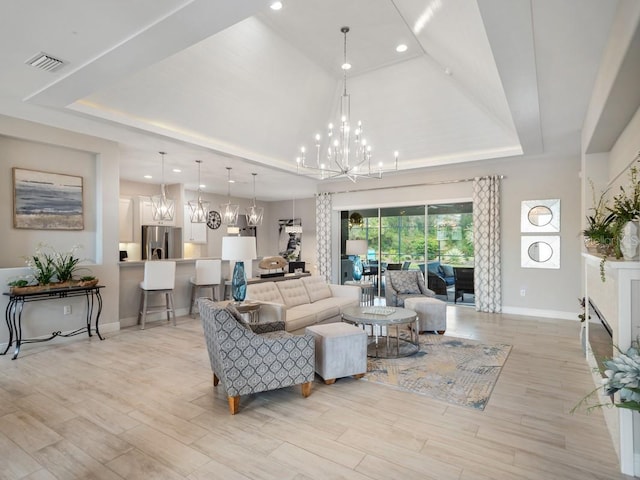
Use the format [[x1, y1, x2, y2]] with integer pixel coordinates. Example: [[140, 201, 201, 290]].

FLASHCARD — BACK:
[[305, 322, 367, 385]]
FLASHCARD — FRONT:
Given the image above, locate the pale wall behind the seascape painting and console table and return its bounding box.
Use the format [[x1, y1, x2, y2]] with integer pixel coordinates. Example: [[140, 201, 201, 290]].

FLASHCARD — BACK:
[[0, 116, 119, 344]]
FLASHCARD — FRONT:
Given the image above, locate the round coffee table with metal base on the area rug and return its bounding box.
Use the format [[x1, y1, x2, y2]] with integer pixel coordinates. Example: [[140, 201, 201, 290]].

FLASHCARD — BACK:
[[342, 306, 420, 358]]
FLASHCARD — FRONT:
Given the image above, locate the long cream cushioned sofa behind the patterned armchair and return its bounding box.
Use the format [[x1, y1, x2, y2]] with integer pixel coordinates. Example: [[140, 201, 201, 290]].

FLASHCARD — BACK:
[[246, 275, 361, 334]]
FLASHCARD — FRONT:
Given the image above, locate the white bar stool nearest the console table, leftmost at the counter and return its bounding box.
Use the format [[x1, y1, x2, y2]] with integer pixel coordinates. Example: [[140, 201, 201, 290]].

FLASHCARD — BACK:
[[138, 260, 176, 330]]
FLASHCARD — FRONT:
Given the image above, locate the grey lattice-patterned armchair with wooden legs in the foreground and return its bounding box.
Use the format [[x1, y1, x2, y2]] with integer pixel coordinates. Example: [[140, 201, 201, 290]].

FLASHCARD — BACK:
[[198, 298, 315, 415]]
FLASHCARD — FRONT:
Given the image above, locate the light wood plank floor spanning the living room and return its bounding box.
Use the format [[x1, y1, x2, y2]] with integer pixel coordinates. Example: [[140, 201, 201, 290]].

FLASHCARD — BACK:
[[0, 307, 629, 480]]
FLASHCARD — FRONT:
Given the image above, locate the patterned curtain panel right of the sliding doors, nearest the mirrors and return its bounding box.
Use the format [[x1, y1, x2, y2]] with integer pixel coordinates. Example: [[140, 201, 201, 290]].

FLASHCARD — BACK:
[[473, 175, 502, 313]]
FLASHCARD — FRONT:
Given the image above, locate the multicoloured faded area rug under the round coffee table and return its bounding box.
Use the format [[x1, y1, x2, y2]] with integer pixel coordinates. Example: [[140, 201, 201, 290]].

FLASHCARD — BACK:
[[364, 334, 511, 410]]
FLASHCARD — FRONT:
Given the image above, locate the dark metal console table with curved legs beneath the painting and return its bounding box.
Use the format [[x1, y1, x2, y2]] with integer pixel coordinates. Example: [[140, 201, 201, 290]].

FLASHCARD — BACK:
[[0, 285, 104, 360]]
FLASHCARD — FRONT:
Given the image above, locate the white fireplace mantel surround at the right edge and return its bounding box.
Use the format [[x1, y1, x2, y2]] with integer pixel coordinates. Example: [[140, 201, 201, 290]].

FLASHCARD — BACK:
[[582, 253, 640, 475]]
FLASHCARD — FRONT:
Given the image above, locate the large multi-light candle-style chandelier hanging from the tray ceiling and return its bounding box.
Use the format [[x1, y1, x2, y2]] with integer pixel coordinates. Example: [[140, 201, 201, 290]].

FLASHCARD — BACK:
[[296, 27, 398, 183]]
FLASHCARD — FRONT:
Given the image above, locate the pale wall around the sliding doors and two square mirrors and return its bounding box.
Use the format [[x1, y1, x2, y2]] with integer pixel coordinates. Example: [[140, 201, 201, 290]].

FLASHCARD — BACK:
[[323, 156, 582, 320]]
